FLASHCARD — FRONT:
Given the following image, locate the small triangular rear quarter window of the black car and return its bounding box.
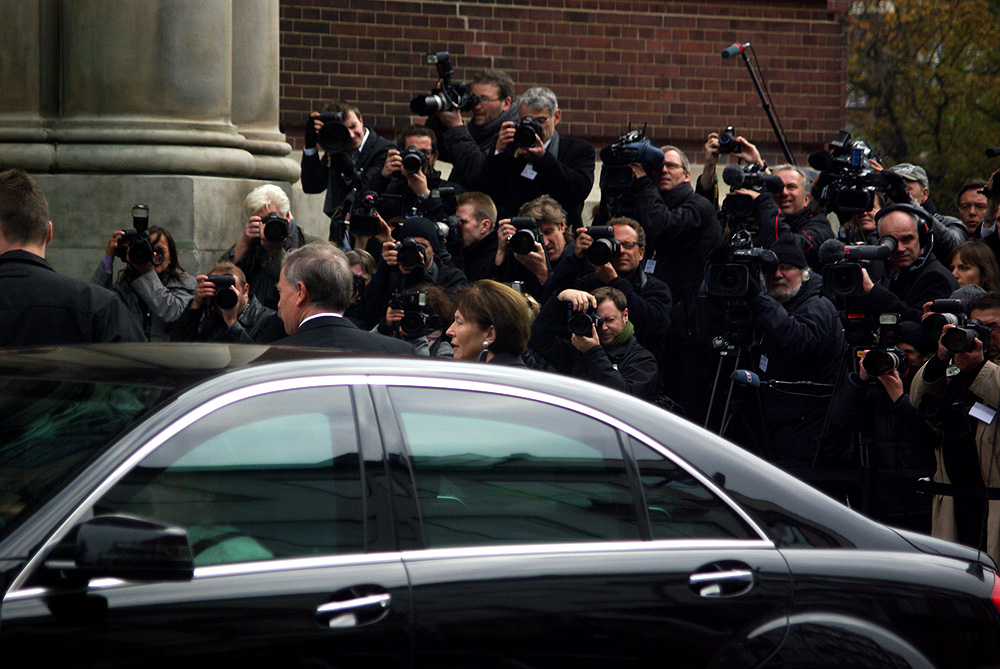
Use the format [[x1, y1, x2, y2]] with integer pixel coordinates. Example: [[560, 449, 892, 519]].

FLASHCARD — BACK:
[[627, 437, 759, 539]]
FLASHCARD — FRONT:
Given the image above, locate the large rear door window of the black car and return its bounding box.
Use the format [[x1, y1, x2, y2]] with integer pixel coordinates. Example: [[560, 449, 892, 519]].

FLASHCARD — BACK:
[[389, 388, 640, 548]]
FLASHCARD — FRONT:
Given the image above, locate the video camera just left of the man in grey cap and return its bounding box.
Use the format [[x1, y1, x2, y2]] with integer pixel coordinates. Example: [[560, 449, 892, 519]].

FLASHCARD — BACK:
[[809, 130, 886, 221]]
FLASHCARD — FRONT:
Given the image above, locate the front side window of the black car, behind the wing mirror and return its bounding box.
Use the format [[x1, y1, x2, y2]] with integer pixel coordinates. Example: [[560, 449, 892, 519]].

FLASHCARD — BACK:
[[95, 387, 363, 565]]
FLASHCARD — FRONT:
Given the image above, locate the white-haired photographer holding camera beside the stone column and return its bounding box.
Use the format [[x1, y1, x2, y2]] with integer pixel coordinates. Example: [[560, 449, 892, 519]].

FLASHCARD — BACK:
[[219, 184, 307, 309]]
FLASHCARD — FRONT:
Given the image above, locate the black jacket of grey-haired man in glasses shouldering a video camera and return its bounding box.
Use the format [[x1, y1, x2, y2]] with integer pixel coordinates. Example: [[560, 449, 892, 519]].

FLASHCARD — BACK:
[[635, 177, 722, 341]]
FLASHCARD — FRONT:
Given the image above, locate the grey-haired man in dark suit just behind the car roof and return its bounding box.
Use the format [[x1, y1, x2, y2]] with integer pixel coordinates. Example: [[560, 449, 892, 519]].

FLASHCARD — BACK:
[[275, 242, 413, 354]]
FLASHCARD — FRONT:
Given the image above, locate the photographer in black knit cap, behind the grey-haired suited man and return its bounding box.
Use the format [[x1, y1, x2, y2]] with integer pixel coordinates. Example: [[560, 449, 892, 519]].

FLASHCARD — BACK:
[[357, 216, 467, 330]]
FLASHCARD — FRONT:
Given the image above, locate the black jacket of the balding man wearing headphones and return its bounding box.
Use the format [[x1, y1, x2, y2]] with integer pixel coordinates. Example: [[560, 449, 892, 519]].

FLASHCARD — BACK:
[[862, 255, 958, 323]]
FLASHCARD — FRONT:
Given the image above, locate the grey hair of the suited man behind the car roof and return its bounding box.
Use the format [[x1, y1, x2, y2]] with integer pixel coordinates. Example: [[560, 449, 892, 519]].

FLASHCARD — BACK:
[[284, 242, 354, 314]]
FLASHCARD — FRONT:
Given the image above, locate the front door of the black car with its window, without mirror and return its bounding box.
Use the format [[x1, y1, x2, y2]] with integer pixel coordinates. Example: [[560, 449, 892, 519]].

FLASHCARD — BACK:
[[0, 380, 410, 667]]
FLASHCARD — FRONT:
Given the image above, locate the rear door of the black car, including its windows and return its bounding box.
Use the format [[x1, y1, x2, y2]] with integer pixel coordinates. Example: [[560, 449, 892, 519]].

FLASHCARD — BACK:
[[376, 384, 791, 668]]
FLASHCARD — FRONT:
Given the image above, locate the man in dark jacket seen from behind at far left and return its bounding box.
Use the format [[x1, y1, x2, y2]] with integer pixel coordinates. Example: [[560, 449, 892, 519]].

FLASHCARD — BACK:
[[0, 170, 146, 347]]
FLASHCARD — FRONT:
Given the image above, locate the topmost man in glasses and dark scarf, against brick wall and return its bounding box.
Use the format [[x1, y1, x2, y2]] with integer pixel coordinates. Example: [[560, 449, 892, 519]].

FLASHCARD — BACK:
[[424, 69, 517, 190]]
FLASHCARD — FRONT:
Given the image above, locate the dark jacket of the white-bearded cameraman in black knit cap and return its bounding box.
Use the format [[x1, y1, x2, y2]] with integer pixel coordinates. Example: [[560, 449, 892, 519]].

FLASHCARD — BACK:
[[750, 275, 847, 468]]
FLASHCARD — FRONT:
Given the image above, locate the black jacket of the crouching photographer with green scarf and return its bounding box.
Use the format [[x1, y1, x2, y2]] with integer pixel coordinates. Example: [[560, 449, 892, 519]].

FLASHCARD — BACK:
[[528, 296, 660, 400]]
